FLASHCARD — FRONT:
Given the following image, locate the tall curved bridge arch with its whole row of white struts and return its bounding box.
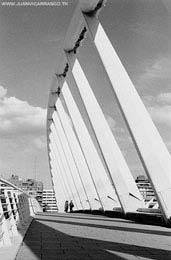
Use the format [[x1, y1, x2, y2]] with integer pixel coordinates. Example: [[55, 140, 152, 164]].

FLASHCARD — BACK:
[[47, 0, 171, 221]]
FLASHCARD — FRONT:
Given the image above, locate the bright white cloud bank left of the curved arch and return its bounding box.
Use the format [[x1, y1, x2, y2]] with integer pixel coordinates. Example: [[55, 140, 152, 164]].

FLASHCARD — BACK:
[[0, 86, 46, 156]]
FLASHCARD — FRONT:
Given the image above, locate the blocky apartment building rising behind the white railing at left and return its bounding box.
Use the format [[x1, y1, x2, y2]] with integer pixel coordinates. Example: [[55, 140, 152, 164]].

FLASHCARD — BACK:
[[9, 174, 43, 205]]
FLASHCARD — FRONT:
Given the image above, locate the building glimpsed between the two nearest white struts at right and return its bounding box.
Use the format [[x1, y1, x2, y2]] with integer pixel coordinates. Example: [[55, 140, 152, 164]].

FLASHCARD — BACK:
[[135, 175, 156, 202]]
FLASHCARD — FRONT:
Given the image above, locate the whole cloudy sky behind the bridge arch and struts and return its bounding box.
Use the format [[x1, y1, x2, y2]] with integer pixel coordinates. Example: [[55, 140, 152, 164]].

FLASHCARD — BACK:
[[0, 0, 171, 188]]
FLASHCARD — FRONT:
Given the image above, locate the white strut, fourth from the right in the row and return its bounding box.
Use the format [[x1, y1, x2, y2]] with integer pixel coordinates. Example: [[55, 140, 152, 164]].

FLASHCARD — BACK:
[[56, 99, 97, 209]]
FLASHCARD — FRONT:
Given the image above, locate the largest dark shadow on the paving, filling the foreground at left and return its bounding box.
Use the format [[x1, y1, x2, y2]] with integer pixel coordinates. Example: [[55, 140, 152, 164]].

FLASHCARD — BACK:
[[15, 220, 125, 260]]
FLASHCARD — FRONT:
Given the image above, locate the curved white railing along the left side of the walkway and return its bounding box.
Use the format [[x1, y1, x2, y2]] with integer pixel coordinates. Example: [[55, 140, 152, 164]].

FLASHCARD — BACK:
[[0, 179, 42, 247]]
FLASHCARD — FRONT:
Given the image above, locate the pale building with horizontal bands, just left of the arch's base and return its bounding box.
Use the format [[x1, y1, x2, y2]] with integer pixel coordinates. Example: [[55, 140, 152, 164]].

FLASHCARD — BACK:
[[42, 189, 58, 213]]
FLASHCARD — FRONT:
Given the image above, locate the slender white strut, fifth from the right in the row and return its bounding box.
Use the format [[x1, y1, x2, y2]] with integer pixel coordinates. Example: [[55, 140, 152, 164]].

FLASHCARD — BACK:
[[52, 111, 87, 209]]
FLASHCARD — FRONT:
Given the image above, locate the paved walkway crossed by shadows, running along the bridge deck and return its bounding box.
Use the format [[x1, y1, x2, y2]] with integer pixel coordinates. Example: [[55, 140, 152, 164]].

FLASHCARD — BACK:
[[16, 213, 171, 260]]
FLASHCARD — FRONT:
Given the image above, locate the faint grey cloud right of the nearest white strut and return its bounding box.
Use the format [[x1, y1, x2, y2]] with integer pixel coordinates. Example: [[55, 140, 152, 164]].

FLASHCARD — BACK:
[[137, 56, 171, 130]]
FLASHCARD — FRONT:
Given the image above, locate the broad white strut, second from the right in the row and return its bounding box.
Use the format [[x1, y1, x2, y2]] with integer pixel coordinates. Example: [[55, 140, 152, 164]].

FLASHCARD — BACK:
[[68, 56, 143, 213]]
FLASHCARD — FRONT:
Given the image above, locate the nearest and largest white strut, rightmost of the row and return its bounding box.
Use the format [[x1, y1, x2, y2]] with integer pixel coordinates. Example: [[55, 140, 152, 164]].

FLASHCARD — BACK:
[[84, 15, 171, 220]]
